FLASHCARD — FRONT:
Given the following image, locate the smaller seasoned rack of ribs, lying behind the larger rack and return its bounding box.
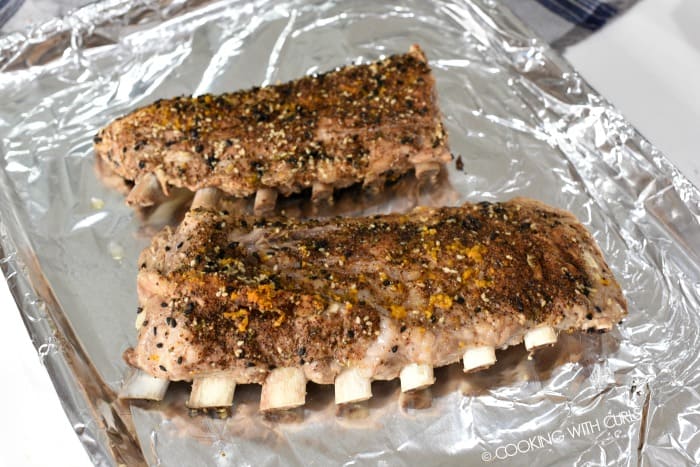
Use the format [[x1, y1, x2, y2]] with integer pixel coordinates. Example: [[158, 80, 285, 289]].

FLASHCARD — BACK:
[[94, 45, 451, 214]]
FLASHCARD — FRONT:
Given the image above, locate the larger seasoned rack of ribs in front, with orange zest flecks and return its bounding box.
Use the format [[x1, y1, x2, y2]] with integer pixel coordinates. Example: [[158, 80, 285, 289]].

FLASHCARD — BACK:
[[122, 195, 627, 411]]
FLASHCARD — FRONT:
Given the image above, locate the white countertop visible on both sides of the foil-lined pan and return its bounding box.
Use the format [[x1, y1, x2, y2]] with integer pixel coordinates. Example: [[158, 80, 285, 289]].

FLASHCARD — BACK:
[[0, 0, 700, 467]]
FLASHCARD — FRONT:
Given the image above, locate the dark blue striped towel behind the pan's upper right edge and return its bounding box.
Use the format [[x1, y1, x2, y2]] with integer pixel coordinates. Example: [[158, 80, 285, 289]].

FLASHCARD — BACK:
[[501, 0, 636, 49]]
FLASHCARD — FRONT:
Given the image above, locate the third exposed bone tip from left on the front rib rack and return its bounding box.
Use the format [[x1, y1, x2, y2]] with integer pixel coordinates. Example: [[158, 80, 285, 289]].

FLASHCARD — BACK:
[[260, 367, 306, 412]]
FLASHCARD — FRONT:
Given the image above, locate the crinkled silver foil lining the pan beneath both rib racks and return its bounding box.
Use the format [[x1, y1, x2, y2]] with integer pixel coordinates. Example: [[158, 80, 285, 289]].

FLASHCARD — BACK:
[[0, 0, 700, 466]]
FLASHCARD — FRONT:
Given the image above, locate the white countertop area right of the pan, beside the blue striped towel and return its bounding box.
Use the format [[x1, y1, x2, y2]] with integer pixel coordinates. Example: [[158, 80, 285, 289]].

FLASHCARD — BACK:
[[564, 0, 700, 187]]
